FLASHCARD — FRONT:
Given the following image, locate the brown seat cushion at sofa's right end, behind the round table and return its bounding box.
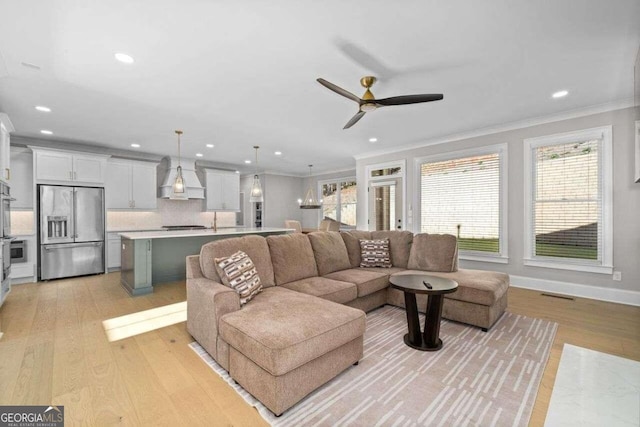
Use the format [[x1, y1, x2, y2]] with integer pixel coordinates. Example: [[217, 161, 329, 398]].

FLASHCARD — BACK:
[[396, 268, 509, 306]]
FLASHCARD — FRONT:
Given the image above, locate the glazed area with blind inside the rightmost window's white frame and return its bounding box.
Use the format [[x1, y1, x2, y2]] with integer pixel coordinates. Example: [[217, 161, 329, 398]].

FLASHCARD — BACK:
[[532, 140, 602, 260]]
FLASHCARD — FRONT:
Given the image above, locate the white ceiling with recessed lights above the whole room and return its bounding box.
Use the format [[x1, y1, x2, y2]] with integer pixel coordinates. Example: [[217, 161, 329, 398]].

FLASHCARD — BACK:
[[0, 0, 640, 174]]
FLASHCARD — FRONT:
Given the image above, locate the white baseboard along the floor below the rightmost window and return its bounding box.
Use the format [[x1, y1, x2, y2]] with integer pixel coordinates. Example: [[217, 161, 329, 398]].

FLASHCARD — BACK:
[[510, 276, 640, 306]]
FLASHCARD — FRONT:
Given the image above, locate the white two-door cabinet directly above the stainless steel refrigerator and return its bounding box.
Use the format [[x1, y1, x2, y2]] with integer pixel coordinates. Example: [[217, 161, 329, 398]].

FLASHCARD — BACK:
[[30, 147, 110, 184]]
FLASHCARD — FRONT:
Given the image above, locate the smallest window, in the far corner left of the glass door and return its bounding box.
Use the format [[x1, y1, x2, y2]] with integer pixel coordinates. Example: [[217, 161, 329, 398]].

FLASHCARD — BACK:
[[320, 178, 357, 227]]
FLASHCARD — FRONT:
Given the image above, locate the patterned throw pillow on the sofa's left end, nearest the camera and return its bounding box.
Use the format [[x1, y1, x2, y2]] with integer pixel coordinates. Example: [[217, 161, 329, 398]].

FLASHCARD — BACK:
[[215, 251, 262, 306]]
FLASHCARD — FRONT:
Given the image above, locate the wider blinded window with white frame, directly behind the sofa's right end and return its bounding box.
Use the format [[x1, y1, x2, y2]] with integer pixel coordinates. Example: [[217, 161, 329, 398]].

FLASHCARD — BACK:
[[418, 145, 507, 262]]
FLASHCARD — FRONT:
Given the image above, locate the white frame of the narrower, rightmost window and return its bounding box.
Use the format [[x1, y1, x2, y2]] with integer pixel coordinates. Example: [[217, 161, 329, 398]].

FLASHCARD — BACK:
[[523, 125, 613, 274]]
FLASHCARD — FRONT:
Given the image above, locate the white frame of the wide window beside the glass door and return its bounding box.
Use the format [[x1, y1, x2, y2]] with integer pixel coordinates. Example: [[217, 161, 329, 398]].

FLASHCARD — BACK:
[[414, 143, 509, 264]]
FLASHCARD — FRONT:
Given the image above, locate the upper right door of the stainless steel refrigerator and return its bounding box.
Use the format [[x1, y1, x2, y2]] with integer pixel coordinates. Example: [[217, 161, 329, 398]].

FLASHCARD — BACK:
[[74, 187, 104, 242]]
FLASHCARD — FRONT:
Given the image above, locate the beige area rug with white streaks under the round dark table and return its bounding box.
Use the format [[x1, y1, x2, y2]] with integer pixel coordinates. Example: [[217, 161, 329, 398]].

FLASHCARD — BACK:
[[190, 306, 557, 426]]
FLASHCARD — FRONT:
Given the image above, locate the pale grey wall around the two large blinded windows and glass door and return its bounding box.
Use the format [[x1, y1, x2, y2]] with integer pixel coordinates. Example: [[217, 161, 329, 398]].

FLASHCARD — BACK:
[[356, 108, 640, 298]]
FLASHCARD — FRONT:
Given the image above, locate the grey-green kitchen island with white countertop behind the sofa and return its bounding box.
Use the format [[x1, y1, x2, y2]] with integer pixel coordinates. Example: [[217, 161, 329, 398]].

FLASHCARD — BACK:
[[120, 227, 294, 295]]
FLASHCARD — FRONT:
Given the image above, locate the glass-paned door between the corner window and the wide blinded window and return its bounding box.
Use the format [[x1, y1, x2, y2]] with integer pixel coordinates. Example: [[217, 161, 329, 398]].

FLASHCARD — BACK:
[[369, 178, 404, 230]]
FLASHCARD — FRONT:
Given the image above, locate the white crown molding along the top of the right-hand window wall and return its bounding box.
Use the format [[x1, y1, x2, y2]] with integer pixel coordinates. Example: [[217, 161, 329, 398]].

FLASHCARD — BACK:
[[353, 97, 635, 160]]
